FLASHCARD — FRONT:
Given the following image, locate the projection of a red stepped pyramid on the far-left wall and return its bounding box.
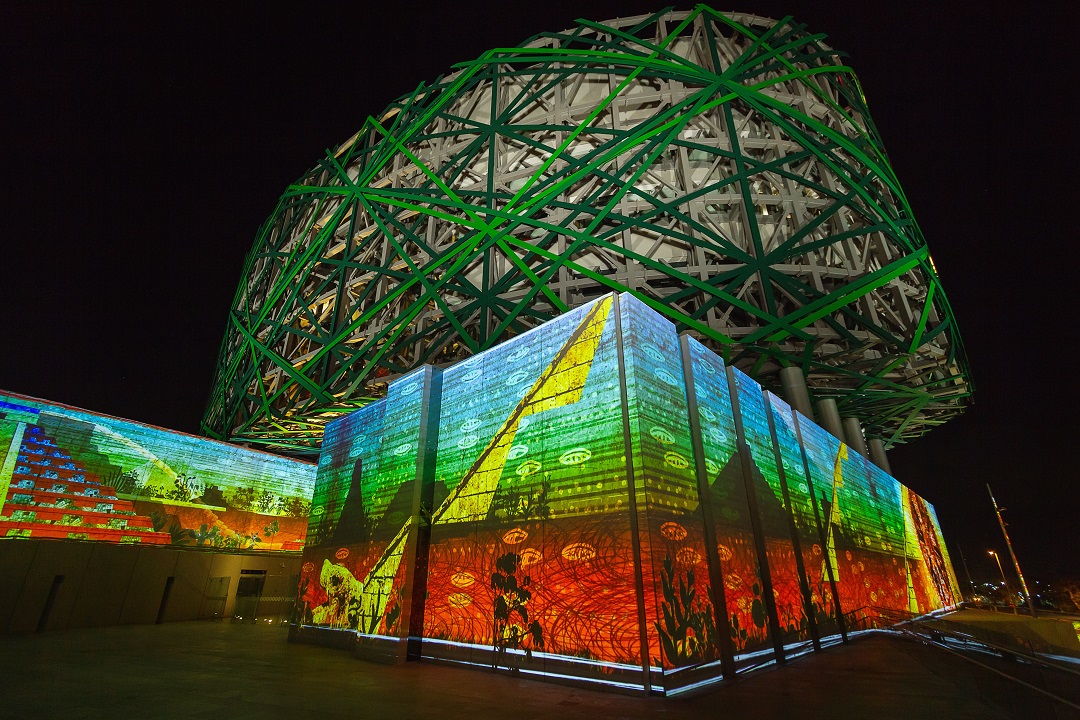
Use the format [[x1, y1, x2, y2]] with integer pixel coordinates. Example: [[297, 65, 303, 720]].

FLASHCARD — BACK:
[[0, 394, 315, 553]]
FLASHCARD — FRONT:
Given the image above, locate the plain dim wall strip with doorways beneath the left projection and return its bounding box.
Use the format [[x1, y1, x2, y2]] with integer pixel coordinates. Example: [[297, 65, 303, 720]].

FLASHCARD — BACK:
[[0, 540, 300, 636]]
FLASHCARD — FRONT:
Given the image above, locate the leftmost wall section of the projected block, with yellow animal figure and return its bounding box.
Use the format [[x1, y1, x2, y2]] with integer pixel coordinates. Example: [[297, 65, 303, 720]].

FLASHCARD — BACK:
[[293, 367, 445, 660]]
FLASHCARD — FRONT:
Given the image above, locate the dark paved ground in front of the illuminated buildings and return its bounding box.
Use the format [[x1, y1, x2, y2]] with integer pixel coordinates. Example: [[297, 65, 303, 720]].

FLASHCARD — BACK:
[[0, 622, 1077, 720]]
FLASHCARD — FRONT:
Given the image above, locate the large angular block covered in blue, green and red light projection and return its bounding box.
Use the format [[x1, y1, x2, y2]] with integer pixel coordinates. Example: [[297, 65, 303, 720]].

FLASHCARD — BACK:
[[294, 295, 956, 693]]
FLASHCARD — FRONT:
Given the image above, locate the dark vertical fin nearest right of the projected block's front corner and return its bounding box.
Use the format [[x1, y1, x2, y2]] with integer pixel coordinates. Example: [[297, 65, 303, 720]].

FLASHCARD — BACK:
[[679, 335, 735, 680]]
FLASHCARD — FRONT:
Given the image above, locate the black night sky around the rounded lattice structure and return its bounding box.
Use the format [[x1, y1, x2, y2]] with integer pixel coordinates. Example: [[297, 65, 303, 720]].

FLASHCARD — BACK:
[[0, 0, 1080, 587]]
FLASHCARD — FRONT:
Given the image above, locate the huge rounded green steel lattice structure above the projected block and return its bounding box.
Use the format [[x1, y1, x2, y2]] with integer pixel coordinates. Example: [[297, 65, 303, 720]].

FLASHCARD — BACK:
[[203, 5, 972, 452]]
